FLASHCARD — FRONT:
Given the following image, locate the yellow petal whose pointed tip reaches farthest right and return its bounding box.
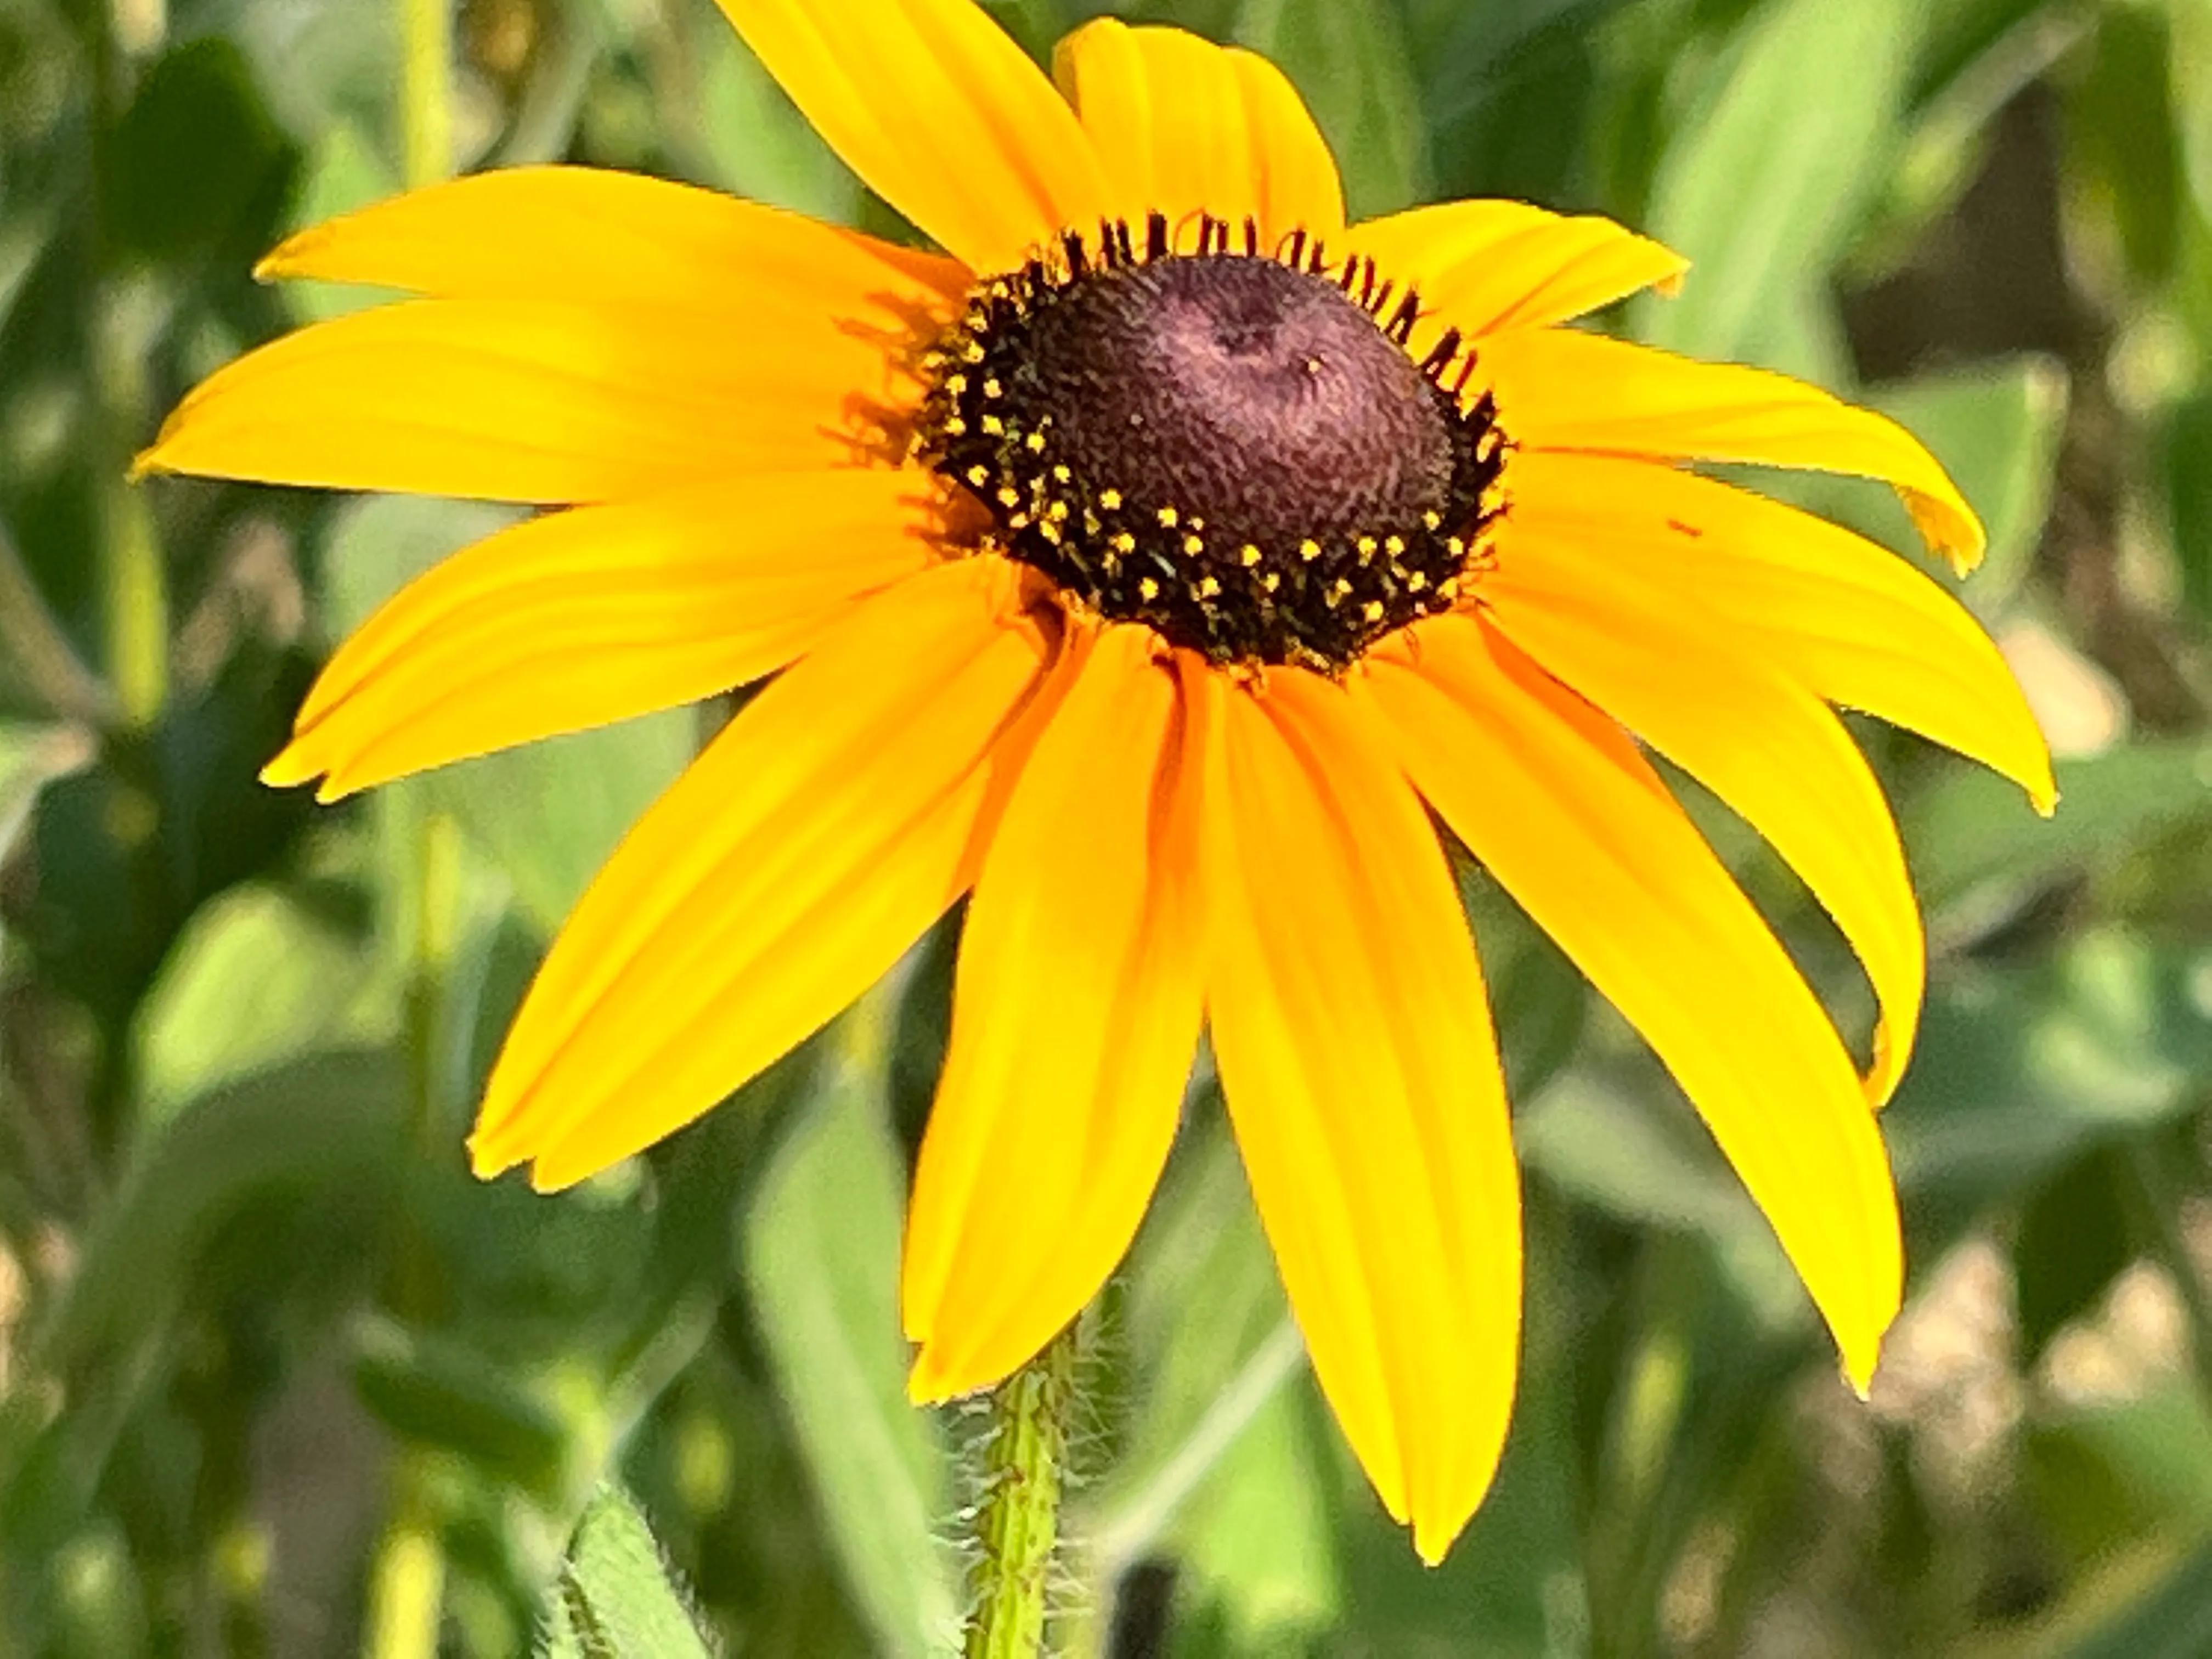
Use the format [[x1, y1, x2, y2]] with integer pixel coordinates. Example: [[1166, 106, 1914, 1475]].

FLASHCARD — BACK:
[[1504, 454, 2057, 812]]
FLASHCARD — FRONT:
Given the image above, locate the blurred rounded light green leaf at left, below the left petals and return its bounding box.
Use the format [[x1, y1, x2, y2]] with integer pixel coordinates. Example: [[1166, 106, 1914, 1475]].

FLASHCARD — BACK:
[[135, 883, 400, 1128]]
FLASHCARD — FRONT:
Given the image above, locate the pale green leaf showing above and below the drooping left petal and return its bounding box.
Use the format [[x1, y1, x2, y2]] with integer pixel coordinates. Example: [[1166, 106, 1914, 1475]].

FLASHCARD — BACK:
[[323, 495, 695, 931]]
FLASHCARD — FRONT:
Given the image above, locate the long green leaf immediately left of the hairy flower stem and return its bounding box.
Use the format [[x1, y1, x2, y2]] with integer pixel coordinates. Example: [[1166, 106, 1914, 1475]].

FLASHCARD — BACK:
[[746, 1005, 958, 1659]]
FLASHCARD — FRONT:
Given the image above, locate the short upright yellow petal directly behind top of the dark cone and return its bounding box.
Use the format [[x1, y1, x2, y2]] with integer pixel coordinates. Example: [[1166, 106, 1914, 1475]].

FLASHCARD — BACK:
[[1053, 18, 1345, 252]]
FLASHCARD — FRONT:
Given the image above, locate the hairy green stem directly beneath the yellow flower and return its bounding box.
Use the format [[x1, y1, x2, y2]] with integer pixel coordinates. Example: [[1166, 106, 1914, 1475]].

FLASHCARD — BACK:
[[960, 1323, 1075, 1659]]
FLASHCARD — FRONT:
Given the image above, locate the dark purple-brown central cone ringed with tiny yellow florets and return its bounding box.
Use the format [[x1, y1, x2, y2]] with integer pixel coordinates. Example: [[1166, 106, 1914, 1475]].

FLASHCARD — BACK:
[[913, 215, 1504, 675]]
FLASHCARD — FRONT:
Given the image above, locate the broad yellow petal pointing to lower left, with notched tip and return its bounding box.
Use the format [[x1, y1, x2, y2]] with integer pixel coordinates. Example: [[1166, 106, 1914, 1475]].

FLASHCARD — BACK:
[[469, 557, 1046, 1190]]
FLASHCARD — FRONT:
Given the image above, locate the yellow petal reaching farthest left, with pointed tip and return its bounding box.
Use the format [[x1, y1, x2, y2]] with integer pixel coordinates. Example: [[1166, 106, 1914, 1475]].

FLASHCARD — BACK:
[[139, 296, 918, 502]]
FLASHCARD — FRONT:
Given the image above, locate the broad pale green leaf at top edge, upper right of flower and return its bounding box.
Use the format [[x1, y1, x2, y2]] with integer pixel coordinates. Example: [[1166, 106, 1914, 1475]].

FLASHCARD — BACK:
[[1637, 0, 1922, 360]]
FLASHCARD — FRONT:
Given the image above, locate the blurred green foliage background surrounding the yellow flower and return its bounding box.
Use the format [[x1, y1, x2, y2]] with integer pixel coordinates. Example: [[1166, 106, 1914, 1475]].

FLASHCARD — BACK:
[[0, 0, 2212, 1659]]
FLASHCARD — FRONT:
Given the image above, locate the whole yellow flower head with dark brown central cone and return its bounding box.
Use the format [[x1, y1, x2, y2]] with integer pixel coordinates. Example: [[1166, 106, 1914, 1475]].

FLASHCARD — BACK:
[[144, 0, 2051, 1560]]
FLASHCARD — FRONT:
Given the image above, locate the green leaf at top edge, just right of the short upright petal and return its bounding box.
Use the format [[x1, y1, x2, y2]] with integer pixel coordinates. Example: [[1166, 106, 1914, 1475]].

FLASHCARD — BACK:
[[1234, 0, 1427, 219]]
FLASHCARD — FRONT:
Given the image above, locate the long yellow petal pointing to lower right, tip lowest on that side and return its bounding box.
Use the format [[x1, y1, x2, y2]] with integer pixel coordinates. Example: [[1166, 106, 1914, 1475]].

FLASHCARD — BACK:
[[1358, 615, 1905, 1391]]
